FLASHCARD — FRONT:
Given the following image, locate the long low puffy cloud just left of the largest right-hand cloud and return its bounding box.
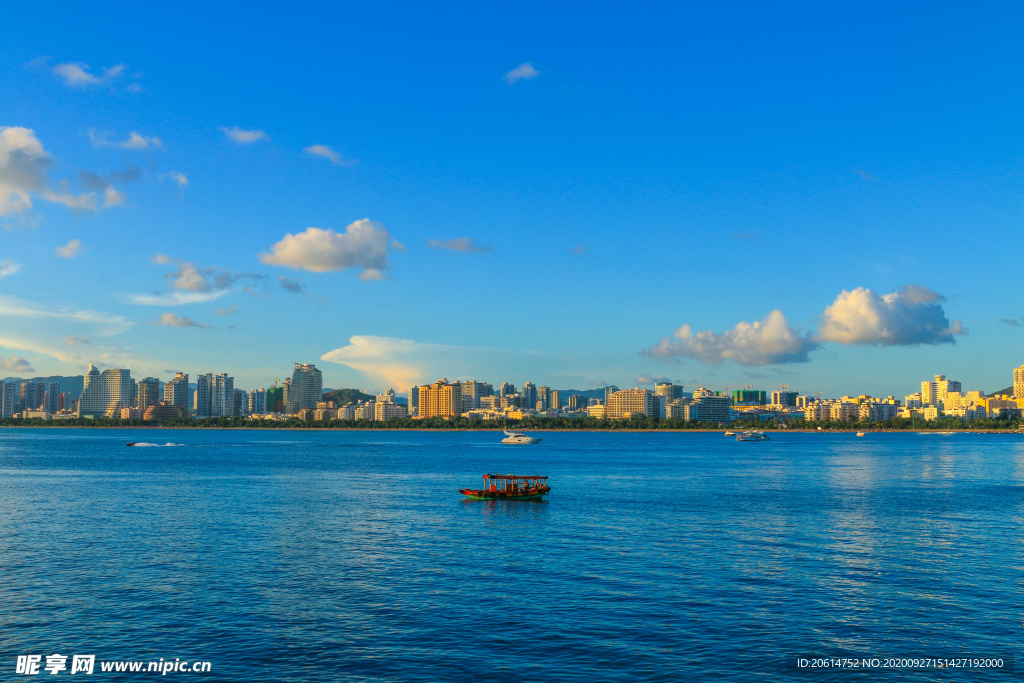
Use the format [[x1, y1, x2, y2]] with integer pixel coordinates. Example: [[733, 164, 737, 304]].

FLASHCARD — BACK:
[[647, 309, 818, 366]]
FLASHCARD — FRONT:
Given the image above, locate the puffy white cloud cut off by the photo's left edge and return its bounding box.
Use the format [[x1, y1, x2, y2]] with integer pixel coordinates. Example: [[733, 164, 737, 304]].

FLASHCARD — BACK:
[[0, 126, 53, 216]]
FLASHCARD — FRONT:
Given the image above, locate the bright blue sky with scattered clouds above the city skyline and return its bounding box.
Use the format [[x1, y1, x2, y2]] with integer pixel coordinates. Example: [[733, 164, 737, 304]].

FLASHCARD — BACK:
[[0, 2, 1024, 396]]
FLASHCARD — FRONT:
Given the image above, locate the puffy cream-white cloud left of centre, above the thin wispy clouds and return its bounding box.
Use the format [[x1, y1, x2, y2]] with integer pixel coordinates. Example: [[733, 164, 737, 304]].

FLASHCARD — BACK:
[[259, 218, 390, 280]]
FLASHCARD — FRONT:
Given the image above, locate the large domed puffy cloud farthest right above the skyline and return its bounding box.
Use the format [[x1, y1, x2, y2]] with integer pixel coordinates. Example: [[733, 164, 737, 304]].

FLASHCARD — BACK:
[[817, 285, 966, 346]]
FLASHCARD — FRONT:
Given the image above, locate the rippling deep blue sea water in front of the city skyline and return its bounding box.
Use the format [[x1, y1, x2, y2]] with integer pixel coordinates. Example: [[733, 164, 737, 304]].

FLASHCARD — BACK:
[[0, 428, 1024, 681]]
